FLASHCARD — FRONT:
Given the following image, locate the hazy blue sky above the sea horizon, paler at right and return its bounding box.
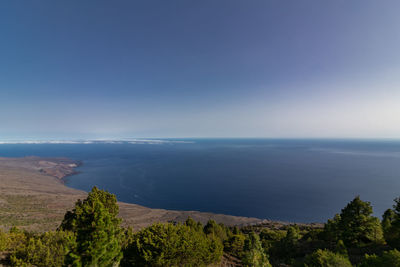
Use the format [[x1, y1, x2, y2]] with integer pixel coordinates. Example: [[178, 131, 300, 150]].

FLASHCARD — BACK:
[[0, 0, 400, 140]]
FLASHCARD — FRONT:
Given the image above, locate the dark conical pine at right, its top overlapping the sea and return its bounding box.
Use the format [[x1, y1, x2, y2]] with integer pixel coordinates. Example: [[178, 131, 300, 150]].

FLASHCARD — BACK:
[[325, 196, 383, 247]]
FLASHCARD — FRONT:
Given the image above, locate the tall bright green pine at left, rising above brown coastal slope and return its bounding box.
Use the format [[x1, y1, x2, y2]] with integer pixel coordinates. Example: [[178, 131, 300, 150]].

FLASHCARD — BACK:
[[60, 187, 122, 266]]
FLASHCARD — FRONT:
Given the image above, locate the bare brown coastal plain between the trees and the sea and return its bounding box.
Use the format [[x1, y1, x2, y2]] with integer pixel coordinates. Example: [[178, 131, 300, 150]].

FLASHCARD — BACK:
[[0, 157, 270, 231]]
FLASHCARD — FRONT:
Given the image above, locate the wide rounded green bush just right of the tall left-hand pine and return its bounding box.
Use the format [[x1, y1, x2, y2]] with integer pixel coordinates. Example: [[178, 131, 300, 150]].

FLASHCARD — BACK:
[[121, 223, 223, 266]]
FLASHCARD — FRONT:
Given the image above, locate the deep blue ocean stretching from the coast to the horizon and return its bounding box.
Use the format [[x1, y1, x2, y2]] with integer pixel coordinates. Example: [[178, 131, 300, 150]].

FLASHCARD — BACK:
[[0, 139, 400, 222]]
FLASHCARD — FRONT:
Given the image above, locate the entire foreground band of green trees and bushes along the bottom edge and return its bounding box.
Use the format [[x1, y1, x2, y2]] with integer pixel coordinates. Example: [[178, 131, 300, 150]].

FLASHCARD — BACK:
[[0, 187, 400, 267]]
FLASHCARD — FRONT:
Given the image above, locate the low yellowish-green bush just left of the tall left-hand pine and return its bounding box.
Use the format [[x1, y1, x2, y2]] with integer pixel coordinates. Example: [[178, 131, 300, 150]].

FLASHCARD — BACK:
[[10, 231, 75, 267]]
